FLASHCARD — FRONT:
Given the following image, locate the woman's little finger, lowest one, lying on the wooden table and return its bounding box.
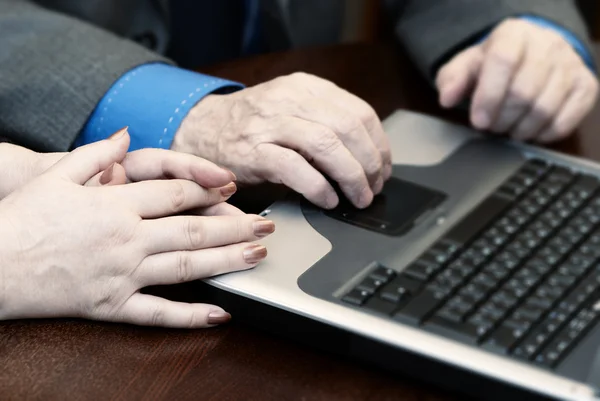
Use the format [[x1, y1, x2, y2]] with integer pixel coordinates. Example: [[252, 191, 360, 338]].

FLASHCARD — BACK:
[[113, 293, 231, 329]]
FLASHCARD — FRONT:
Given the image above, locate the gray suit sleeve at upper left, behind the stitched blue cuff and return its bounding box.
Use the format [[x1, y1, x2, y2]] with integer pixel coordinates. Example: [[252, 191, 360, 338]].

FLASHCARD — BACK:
[[0, 0, 171, 151]]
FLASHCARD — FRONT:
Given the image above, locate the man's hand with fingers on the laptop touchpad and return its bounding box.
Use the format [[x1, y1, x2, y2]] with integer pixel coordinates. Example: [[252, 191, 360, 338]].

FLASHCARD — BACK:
[[172, 73, 392, 208]]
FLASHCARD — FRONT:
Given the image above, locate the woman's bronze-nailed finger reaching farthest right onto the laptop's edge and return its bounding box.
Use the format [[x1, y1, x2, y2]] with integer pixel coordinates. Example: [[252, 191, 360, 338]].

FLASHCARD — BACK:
[[139, 215, 275, 254]]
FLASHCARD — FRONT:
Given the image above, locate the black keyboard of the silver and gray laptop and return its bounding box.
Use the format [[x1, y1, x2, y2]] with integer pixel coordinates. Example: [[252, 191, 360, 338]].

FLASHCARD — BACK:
[[342, 159, 600, 368]]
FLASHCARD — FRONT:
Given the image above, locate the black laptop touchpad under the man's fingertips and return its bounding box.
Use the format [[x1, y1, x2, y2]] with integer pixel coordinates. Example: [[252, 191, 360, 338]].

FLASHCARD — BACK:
[[325, 177, 446, 235]]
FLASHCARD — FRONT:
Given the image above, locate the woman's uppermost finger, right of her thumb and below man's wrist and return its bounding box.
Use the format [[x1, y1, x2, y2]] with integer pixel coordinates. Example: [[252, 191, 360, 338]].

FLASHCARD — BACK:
[[123, 149, 235, 188]]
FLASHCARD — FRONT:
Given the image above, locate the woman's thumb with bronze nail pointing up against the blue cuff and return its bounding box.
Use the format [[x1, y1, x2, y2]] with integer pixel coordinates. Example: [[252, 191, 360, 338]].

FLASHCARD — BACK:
[[48, 127, 130, 185]]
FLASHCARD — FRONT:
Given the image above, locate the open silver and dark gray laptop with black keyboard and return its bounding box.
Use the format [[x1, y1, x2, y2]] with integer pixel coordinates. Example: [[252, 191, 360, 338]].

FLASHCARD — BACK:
[[200, 111, 600, 401]]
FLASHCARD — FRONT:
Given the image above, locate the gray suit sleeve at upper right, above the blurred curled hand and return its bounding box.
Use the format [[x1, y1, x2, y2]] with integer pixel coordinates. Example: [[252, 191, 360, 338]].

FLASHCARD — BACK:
[[388, 0, 591, 79]]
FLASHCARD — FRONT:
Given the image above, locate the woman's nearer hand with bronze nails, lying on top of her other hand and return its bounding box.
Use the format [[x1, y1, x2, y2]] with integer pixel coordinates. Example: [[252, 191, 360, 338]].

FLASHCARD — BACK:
[[0, 131, 274, 328]]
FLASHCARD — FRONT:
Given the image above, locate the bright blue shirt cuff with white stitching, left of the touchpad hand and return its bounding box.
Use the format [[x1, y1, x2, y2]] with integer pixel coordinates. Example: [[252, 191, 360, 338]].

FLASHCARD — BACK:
[[74, 63, 244, 150]]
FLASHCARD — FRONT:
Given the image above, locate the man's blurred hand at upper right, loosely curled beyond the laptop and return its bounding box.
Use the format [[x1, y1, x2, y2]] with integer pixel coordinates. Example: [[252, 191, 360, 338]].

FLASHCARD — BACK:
[[437, 19, 598, 143]]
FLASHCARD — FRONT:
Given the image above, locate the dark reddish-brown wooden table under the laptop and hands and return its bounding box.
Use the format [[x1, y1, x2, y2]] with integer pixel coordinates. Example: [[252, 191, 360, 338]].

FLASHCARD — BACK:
[[0, 45, 600, 401]]
